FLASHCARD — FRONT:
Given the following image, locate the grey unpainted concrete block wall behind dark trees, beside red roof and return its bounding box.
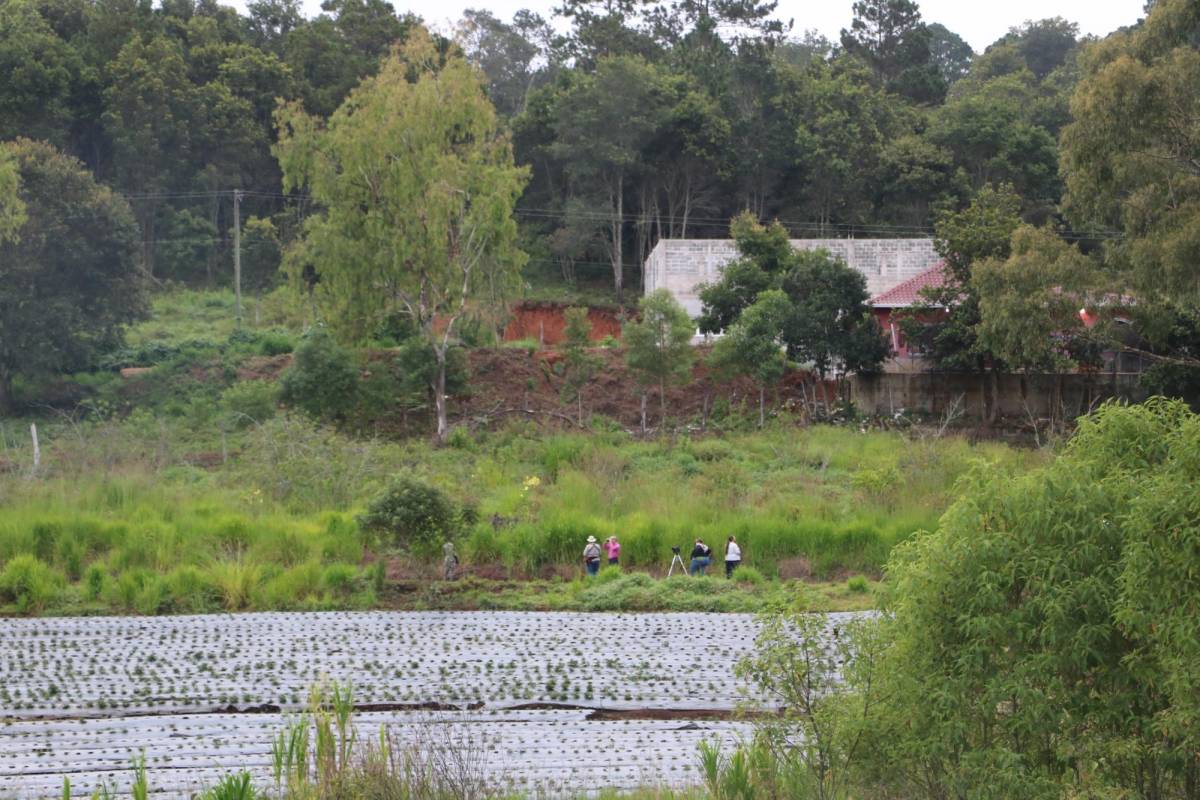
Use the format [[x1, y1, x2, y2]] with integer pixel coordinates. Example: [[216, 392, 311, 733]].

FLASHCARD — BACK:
[[646, 239, 940, 317]]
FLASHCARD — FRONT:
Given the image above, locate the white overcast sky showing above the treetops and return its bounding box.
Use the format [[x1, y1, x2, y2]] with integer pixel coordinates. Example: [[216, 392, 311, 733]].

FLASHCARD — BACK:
[[234, 0, 1144, 52]]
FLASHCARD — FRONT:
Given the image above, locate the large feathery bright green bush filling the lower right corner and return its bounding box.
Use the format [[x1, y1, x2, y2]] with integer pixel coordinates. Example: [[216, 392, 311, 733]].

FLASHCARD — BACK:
[[863, 398, 1200, 798]]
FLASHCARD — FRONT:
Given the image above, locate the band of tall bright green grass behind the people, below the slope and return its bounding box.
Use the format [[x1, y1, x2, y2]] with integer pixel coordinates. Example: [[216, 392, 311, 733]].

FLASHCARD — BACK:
[[0, 415, 1043, 613]]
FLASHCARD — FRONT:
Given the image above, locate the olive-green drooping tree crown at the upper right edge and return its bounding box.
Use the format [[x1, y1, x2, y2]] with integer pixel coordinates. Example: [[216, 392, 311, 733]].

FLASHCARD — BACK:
[[1063, 0, 1200, 306]]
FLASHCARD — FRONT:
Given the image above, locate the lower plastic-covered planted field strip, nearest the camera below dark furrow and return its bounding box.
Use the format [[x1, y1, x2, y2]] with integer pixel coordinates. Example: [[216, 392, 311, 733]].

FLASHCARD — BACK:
[[0, 711, 745, 798]]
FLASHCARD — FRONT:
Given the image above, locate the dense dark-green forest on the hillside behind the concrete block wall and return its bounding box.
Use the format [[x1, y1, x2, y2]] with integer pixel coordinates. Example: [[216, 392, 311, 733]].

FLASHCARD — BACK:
[[0, 0, 1081, 296]]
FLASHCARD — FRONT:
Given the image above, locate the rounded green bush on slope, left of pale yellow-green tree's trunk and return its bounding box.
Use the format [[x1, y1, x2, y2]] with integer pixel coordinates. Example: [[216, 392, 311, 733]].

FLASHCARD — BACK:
[[280, 327, 359, 419]]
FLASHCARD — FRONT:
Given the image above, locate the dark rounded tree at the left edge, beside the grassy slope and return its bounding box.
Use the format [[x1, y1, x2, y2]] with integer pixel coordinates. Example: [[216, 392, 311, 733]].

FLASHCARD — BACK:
[[0, 139, 146, 414]]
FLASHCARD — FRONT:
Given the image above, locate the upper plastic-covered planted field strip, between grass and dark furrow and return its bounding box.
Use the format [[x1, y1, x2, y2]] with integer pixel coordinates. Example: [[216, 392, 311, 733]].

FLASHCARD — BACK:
[[0, 612, 844, 718]]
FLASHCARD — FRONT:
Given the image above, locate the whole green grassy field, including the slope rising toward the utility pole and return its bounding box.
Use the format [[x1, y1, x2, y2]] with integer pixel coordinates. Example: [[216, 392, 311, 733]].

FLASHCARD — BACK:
[[0, 291, 1045, 614]]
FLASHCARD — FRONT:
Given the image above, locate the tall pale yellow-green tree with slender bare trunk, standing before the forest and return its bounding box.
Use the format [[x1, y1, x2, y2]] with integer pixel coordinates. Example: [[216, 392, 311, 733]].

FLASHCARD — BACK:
[[276, 29, 527, 440]]
